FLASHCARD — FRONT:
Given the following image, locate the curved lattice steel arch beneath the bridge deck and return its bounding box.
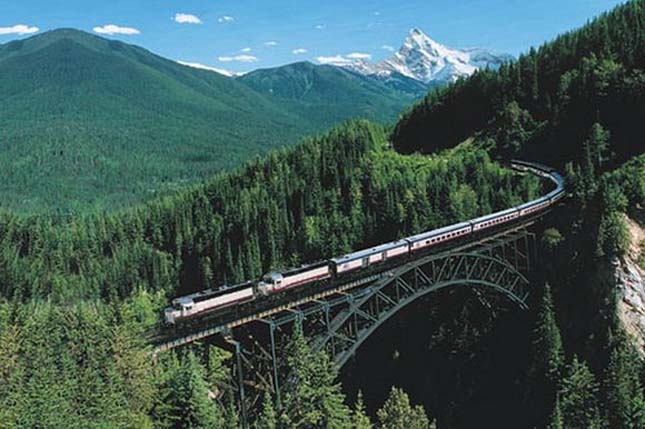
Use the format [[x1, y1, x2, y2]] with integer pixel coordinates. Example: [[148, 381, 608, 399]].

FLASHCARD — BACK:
[[313, 252, 529, 367]]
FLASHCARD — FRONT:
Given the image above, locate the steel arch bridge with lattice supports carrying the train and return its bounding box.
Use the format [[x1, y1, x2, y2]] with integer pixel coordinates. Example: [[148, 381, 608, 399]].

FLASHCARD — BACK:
[[209, 225, 537, 422]]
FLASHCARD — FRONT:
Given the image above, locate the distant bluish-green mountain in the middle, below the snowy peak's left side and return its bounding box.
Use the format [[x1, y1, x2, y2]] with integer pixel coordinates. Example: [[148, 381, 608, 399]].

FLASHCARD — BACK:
[[237, 62, 426, 122]]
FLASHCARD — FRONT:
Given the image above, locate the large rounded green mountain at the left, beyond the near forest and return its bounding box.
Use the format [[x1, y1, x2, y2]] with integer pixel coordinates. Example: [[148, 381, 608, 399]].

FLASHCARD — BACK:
[[0, 29, 409, 211]]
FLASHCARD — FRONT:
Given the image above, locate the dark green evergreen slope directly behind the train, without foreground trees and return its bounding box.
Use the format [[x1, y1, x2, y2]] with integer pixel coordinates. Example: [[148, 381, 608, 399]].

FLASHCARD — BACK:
[[0, 121, 540, 302]]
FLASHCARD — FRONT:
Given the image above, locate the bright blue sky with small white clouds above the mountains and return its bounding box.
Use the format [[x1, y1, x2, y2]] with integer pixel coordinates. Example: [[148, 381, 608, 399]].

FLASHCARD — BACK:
[[0, 0, 622, 71]]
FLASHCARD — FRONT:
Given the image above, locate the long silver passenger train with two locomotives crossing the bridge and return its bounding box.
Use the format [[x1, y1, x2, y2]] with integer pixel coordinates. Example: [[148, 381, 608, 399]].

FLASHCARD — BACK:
[[164, 160, 565, 325]]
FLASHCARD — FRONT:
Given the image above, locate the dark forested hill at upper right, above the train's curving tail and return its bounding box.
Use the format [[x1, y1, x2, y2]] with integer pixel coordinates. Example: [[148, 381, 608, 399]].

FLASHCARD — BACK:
[[393, 0, 645, 166]]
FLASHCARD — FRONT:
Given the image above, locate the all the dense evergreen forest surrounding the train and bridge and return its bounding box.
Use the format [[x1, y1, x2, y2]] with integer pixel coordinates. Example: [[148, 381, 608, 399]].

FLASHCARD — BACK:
[[0, 1, 645, 429]]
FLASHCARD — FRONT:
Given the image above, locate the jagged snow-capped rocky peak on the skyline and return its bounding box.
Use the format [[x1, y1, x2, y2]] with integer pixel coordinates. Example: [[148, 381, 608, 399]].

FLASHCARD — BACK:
[[344, 28, 513, 85]]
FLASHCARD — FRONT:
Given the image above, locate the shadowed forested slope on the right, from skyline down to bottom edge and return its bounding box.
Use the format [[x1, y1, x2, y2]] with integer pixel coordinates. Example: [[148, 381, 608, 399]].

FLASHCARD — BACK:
[[393, 0, 645, 428]]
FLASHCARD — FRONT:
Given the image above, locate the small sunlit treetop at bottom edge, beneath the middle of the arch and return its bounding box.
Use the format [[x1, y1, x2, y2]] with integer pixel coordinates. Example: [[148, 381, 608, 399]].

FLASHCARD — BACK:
[[376, 387, 430, 429]]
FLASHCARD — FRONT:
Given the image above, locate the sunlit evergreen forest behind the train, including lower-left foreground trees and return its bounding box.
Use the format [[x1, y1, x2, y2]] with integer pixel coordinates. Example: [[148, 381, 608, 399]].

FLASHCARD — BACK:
[[0, 122, 542, 428]]
